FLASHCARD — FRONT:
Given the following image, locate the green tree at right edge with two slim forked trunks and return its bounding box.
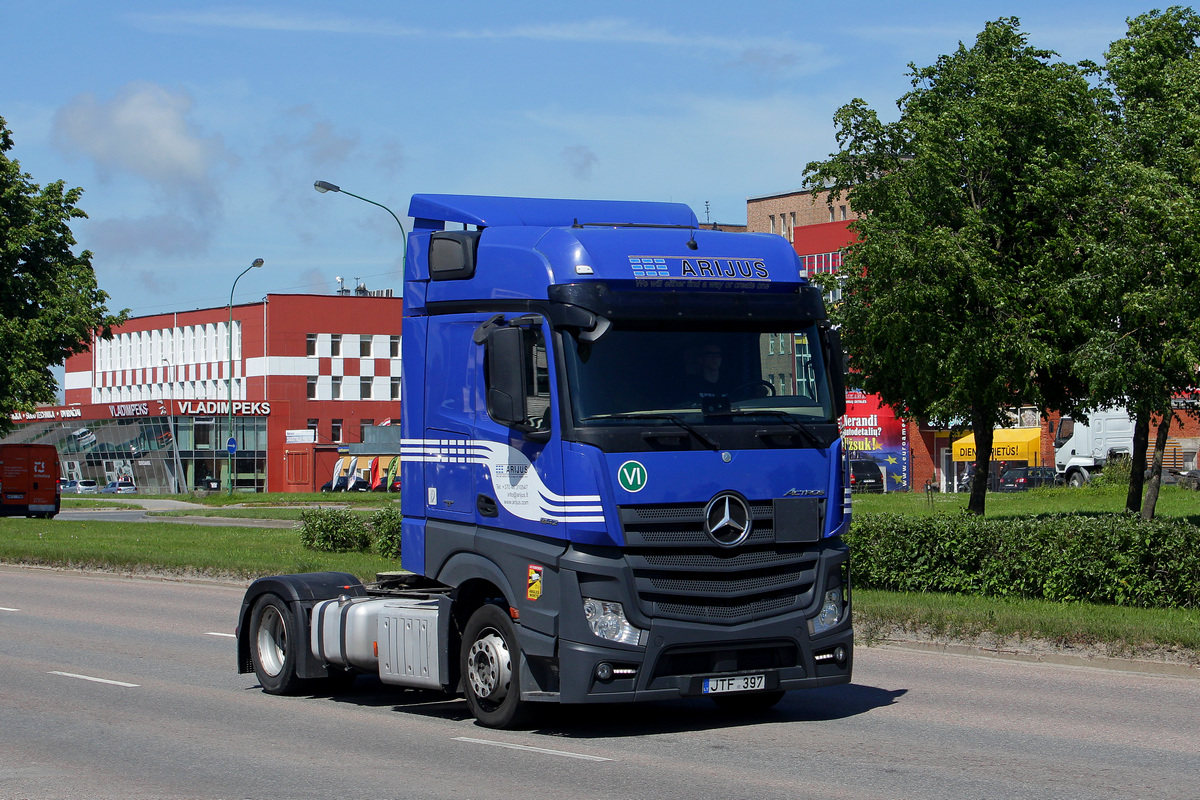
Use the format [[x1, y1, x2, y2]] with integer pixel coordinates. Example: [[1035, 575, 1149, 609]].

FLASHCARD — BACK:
[[1074, 7, 1200, 519]]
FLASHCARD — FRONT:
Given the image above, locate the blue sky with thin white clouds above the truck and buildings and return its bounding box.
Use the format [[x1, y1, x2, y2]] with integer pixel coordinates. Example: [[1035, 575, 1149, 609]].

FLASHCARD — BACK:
[[0, 0, 1154, 315]]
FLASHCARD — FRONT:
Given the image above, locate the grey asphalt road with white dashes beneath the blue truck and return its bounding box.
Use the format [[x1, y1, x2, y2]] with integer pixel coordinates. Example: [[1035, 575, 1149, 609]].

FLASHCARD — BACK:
[[0, 566, 1200, 800]]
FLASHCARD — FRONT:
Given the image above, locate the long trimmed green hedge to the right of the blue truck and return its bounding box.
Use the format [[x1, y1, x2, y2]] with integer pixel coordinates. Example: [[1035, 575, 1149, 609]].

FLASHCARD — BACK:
[[846, 513, 1200, 608]]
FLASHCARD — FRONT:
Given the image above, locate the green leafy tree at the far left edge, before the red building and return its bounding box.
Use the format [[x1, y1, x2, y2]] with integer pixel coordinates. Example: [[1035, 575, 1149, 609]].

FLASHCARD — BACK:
[[0, 118, 128, 434]]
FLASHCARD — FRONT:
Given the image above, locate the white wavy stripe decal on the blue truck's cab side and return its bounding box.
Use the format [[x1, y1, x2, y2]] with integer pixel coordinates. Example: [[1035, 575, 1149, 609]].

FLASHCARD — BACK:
[[400, 439, 605, 523]]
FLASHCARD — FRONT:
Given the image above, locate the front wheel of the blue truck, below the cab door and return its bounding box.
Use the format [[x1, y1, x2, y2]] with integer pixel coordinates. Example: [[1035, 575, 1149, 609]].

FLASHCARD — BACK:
[[460, 603, 529, 728]]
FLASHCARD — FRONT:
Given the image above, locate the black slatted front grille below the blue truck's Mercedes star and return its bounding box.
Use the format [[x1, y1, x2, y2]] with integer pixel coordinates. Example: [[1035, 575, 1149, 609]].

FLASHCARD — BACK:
[[620, 503, 817, 625]]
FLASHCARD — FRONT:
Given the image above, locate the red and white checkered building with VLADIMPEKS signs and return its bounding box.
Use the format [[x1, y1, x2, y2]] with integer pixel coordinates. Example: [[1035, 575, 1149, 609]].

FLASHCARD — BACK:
[[6, 294, 402, 492]]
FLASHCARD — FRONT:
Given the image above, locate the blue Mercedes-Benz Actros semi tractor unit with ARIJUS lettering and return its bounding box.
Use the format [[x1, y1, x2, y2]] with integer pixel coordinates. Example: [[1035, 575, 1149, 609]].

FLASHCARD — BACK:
[[238, 194, 853, 727]]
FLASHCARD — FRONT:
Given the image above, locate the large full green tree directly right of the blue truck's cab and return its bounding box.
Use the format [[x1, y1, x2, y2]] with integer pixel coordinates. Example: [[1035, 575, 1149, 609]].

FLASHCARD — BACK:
[[805, 18, 1106, 515]]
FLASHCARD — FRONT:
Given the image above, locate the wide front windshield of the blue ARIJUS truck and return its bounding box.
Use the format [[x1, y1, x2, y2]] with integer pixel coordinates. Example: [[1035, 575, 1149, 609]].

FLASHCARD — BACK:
[[563, 324, 834, 427]]
